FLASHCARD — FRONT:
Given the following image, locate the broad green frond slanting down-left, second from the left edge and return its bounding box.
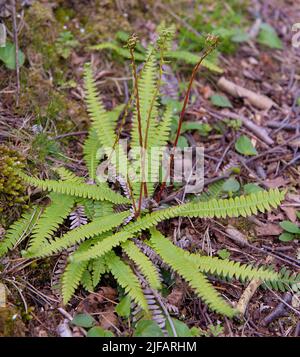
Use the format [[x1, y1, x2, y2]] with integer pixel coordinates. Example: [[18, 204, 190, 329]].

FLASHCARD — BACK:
[[28, 193, 74, 252]]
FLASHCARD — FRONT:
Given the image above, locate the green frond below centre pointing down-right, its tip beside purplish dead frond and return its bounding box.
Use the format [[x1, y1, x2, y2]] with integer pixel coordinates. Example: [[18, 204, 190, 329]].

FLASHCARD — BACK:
[[106, 251, 148, 312]]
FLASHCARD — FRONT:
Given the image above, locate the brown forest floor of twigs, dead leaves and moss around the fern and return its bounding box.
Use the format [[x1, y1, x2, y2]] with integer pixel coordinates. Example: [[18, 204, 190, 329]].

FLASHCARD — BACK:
[[0, 0, 300, 337]]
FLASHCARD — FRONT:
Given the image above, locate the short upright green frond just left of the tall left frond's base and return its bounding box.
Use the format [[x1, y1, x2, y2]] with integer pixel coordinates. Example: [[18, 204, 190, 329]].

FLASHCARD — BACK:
[[83, 129, 101, 180]]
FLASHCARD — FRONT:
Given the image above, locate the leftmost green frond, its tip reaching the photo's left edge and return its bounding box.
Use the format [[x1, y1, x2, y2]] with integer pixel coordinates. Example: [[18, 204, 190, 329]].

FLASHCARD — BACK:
[[0, 207, 41, 257]]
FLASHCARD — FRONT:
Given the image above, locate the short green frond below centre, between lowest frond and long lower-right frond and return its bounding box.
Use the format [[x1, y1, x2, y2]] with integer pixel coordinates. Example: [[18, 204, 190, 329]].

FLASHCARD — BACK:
[[122, 241, 161, 290]]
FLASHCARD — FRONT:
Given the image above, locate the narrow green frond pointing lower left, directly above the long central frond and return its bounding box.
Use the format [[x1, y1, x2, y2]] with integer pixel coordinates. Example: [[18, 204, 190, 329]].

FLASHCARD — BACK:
[[26, 211, 130, 258]]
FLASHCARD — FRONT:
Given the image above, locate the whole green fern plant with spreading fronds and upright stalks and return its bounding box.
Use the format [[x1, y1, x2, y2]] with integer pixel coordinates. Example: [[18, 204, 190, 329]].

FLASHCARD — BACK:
[[0, 29, 300, 317]]
